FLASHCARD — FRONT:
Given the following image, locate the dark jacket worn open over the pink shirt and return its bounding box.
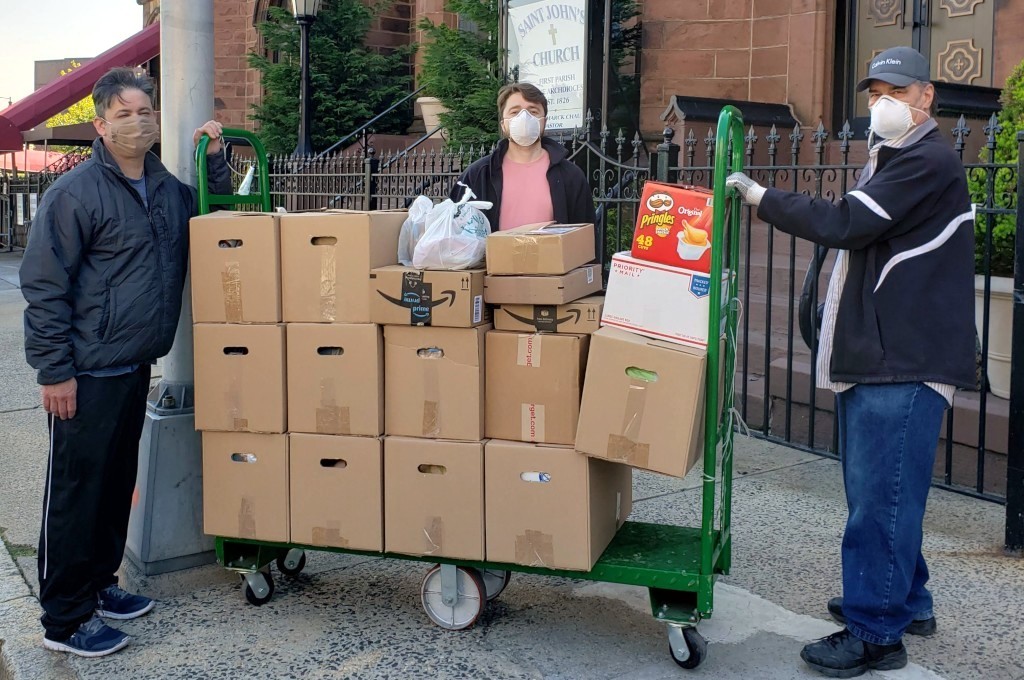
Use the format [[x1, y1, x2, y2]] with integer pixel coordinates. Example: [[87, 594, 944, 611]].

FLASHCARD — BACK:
[[450, 137, 597, 231]]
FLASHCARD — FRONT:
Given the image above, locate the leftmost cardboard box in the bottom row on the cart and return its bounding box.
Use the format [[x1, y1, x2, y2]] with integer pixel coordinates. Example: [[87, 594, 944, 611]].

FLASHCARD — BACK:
[[203, 432, 289, 543]]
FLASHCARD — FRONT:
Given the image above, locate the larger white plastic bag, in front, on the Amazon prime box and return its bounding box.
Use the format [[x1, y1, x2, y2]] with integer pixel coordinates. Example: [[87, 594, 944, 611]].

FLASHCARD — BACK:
[[413, 182, 492, 269]]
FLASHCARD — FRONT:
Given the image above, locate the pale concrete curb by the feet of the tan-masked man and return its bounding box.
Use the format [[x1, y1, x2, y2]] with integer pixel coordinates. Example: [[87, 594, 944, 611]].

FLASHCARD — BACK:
[[0, 542, 79, 680]]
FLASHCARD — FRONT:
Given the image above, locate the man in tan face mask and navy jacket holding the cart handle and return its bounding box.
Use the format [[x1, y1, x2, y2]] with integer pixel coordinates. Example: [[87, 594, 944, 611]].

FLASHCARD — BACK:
[[20, 69, 231, 656]]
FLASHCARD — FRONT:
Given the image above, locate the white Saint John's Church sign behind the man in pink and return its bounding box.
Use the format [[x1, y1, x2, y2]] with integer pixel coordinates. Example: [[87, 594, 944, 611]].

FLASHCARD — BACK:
[[507, 0, 587, 130]]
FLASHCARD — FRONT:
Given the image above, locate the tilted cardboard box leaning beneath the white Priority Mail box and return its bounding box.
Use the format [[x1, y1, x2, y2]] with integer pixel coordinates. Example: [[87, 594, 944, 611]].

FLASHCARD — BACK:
[[575, 328, 707, 477]]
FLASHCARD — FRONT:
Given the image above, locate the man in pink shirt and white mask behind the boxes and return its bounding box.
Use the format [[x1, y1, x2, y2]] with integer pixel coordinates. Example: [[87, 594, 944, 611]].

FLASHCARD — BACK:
[[452, 83, 596, 231]]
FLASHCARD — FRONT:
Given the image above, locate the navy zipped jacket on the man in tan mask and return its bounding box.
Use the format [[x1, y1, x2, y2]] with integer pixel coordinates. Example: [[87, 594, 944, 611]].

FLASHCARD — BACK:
[[20, 138, 231, 385]]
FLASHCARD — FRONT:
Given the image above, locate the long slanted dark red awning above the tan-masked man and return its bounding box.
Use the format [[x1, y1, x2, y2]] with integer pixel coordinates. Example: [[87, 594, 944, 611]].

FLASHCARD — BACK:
[[0, 23, 160, 152]]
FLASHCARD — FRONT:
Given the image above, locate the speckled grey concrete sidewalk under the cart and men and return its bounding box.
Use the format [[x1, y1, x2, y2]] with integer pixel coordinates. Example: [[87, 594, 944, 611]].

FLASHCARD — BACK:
[[0, 250, 1024, 680]]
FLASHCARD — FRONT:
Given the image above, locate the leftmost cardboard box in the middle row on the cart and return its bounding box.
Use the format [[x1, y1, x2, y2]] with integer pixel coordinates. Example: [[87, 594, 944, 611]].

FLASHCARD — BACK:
[[194, 324, 288, 433]]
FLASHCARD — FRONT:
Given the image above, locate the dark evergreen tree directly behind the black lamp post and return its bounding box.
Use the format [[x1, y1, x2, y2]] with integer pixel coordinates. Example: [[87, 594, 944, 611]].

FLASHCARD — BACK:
[[249, 0, 412, 154]]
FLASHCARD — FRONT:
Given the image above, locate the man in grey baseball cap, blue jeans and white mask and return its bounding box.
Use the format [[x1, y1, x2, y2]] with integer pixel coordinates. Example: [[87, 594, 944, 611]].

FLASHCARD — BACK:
[[726, 47, 975, 678]]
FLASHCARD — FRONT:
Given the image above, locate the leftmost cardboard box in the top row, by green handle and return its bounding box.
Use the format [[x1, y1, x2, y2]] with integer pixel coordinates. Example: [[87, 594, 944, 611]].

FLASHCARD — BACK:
[[188, 210, 281, 324]]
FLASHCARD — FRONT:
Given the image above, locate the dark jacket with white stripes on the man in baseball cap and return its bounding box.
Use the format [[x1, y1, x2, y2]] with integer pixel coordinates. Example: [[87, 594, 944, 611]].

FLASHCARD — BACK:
[[758, 124, 975, 389]]
